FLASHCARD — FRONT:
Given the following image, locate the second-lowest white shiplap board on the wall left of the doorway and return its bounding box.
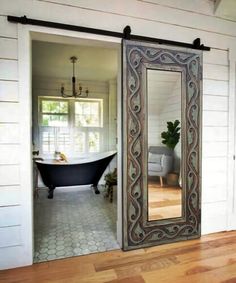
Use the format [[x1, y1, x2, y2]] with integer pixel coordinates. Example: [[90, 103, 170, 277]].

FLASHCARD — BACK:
[[0, 226, 21, 248]]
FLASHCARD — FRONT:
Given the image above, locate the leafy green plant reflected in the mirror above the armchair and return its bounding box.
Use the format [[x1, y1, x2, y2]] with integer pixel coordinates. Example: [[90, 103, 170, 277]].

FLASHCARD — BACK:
[[161, 120, 180, 149]]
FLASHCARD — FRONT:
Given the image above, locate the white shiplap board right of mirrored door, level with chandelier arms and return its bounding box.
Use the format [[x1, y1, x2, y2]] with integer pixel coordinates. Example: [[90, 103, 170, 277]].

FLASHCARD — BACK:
[[203, 79, 229, 96]]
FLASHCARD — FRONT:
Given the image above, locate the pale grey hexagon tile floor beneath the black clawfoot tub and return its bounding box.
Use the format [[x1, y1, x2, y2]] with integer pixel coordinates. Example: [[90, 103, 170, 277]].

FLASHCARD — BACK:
[[34, 187, 119, 262]]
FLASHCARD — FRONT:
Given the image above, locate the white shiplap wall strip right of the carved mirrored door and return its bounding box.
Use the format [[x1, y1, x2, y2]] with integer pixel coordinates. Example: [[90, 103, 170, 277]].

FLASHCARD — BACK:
[[202, 49, 229, 233]]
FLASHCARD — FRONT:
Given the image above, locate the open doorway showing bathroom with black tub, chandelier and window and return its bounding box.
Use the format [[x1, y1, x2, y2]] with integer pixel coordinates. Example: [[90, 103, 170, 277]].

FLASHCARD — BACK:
[[32, 35, 120, 262]]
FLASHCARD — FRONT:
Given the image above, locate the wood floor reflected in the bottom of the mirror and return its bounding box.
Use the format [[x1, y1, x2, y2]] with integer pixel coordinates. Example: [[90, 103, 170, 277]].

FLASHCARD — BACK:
[[148, 180, 182, 221]]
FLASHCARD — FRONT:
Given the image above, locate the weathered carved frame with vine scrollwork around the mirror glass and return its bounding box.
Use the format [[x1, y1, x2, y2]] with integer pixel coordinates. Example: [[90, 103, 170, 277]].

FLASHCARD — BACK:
[[124, 41, 202, 249]]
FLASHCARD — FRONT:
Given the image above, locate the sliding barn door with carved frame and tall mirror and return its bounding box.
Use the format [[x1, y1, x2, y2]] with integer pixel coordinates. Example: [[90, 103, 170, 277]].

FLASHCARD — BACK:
[[123, 40, 202, 250]]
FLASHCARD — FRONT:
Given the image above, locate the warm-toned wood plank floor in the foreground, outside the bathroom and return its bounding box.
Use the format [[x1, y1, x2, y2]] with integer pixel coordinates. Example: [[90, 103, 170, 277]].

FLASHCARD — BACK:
[[0, 231, 236, 283]]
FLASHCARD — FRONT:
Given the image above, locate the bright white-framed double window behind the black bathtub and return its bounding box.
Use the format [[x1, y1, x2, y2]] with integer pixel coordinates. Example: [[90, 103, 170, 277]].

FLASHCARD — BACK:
[[39, 97, 103, 155]]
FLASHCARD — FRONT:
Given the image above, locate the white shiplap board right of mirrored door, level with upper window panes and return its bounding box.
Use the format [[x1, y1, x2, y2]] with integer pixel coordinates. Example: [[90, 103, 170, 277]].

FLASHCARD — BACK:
[[203, 95, 228, 111]]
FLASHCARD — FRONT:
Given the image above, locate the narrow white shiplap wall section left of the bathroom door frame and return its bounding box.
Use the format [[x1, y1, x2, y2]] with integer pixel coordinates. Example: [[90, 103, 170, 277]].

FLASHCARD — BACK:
[[0, 16, 22, 267]]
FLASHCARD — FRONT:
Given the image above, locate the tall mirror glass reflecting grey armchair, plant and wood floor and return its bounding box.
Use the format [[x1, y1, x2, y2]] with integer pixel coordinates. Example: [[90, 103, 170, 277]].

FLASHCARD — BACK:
[[147, 69, 182, 221]]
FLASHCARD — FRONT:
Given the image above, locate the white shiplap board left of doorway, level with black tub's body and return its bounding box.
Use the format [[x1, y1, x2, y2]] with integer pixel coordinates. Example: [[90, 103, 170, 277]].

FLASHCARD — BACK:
[[0, 165, 20, 186]]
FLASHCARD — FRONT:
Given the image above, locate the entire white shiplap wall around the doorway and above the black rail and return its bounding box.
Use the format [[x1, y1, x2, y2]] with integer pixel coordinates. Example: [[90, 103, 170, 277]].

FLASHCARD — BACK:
[[0, 0, 236, 268]]
